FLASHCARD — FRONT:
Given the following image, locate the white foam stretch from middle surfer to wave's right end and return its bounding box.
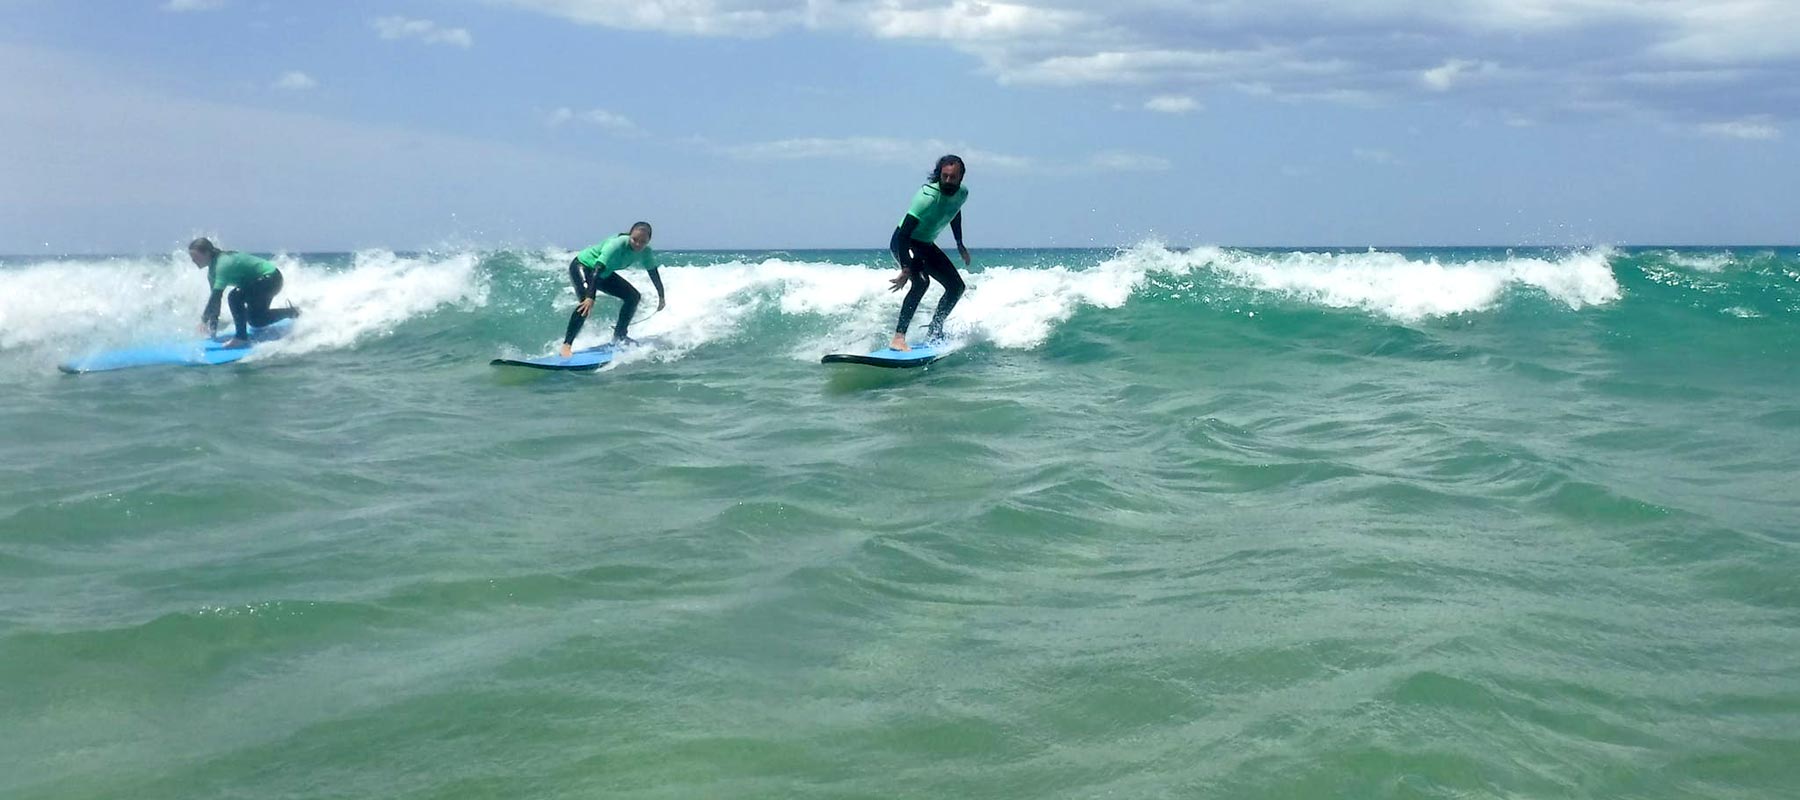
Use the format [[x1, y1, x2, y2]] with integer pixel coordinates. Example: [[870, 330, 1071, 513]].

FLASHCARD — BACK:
[[545, 241, 1620, 360]]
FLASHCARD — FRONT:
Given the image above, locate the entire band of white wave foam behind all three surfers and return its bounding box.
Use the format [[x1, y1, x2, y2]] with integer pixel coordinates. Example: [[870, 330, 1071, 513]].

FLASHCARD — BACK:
[[0, 241, 1620, 371]]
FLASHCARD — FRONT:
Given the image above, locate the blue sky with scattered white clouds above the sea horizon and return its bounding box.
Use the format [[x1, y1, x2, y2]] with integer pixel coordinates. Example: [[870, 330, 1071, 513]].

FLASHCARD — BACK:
[[0, 0, 1800, 254]]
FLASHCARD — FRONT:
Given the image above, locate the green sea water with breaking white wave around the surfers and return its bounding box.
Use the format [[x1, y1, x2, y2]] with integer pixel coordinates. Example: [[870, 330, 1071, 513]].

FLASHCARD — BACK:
[[0, 243, 1800, 798]]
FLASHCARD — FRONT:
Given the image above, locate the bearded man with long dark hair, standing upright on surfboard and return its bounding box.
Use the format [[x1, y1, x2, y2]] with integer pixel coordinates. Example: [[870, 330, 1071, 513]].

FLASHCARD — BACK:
[[887, 155, 968, 350]]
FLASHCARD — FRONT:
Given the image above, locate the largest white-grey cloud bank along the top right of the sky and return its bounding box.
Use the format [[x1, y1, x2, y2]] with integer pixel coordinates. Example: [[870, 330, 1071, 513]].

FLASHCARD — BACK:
[[499, 0, 1800, 121]]
